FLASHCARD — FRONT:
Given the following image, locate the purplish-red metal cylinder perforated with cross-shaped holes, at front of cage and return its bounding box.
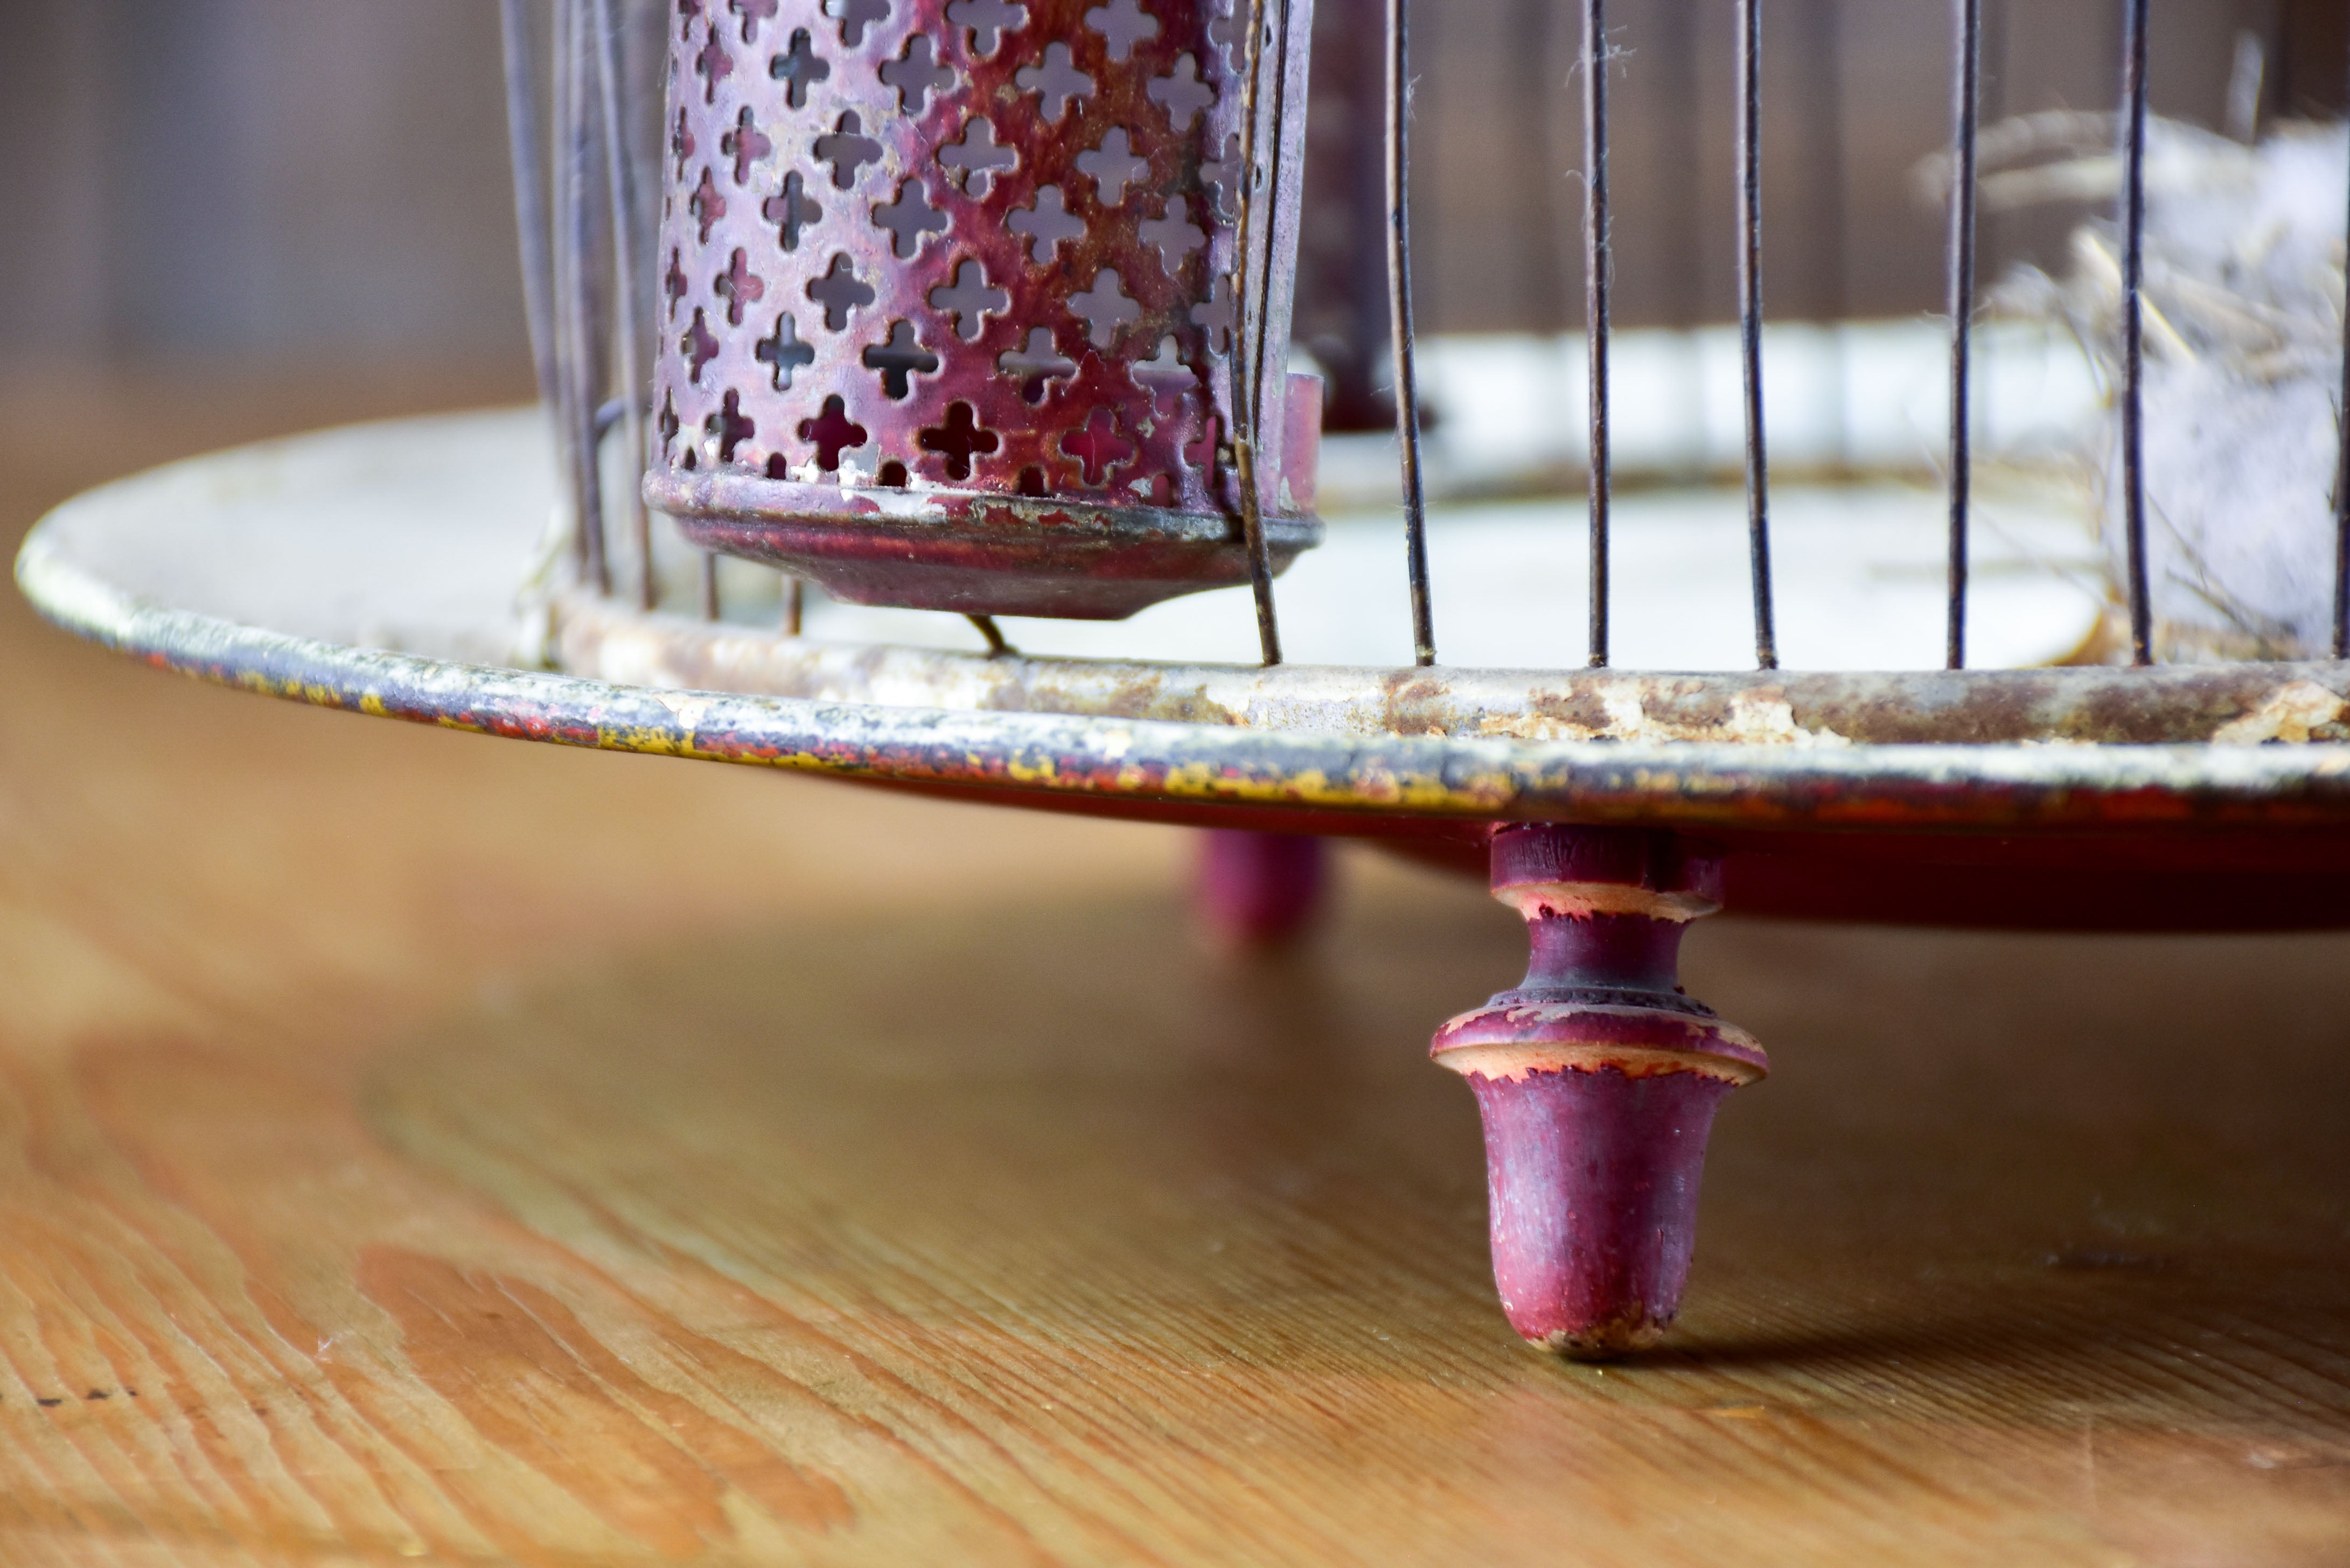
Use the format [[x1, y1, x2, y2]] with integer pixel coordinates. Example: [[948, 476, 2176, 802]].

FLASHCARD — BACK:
[[646, 0, 1321, 618]]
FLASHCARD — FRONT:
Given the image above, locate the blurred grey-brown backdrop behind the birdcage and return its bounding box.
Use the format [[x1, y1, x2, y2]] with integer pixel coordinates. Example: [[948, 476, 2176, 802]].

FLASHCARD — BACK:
[[0, 0, 2350, 395]]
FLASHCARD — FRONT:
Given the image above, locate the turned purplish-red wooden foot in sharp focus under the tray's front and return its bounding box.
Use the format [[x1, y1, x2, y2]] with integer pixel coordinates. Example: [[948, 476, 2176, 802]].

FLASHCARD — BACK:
[[1431, 825, 1769, 1359]]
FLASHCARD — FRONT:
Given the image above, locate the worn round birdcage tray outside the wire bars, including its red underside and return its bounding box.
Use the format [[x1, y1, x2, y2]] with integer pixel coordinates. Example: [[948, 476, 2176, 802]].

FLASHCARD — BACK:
[[17, 412, 2350, 929]]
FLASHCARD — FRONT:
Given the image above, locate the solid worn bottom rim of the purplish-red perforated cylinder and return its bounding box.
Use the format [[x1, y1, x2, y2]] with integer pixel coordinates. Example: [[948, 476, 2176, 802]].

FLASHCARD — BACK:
[[644, 472, 1323, 621]]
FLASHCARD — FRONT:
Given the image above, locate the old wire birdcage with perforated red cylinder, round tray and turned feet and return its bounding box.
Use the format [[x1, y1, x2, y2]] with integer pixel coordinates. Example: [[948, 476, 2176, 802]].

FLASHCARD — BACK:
[[19, 0, 2350, 1354]]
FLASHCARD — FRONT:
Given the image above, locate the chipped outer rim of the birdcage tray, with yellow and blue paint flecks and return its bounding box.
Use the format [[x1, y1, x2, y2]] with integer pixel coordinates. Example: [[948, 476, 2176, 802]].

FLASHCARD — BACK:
[[17, 529, 2350, 834]]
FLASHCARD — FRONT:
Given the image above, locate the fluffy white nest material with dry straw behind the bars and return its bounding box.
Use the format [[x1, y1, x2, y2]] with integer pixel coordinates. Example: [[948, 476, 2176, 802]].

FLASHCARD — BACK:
[[1941, 113, 2350, 660]]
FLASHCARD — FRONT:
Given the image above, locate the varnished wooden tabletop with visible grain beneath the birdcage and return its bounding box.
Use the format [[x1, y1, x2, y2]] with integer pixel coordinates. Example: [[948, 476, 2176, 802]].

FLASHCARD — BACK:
[[0, 362, 2350, 1568]]
